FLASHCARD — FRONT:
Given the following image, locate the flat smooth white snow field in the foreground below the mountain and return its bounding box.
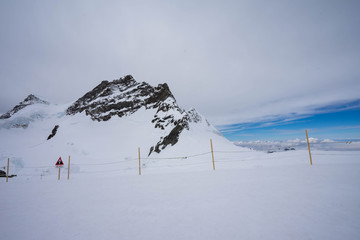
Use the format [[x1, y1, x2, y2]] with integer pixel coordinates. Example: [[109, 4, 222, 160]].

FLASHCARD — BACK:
[[0, 151, 360, 239]]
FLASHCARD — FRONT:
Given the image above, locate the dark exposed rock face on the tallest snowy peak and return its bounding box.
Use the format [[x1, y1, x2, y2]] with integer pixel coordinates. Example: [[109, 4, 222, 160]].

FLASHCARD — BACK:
[[66, 75, 202, 155]]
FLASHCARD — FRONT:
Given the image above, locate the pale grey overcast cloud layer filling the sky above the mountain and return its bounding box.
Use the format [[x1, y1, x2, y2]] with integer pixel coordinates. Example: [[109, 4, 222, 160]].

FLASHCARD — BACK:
[[0, 0, 360, 125]]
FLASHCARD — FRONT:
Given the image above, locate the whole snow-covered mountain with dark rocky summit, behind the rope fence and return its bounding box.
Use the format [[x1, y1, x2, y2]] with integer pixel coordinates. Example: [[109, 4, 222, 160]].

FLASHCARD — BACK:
[[0, 76, 241, 175]]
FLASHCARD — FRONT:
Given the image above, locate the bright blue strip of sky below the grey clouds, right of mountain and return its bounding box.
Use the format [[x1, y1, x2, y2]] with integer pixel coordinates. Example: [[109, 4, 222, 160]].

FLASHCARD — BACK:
[[218, 100, 360, 141]]
